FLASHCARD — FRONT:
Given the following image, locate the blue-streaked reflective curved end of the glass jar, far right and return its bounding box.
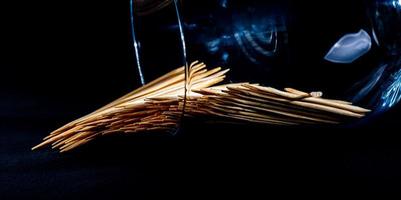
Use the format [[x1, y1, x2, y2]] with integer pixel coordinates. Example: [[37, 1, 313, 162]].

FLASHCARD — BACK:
[[355, 0, 401, 112]]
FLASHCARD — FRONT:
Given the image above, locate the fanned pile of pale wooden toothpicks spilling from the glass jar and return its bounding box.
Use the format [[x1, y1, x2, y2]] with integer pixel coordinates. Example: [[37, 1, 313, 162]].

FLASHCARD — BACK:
[[32, 61, 370, 152]]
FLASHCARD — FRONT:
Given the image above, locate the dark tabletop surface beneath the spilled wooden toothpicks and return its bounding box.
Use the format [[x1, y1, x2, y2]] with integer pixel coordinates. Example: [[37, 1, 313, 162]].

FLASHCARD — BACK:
[[0, 115, 401, 199]]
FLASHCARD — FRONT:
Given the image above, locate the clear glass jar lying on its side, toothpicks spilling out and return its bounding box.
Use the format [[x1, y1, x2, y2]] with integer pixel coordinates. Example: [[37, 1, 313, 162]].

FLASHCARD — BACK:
[[131, 0, 401, 128]]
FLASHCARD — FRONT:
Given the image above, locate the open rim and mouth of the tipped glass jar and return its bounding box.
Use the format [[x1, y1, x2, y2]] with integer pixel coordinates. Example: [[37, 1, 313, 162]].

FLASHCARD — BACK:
[[130, 0, 190, 134]]
